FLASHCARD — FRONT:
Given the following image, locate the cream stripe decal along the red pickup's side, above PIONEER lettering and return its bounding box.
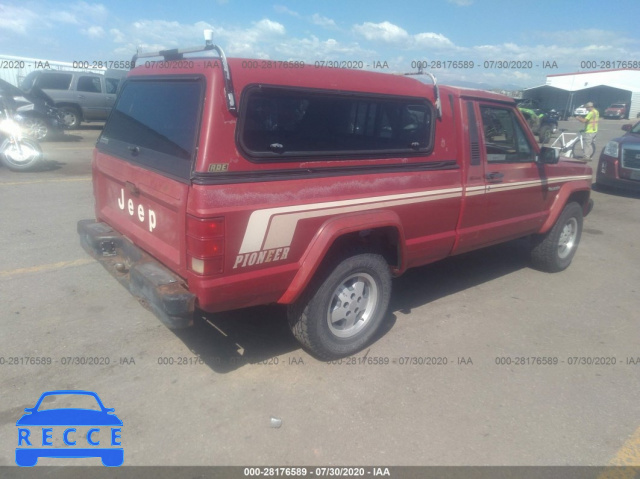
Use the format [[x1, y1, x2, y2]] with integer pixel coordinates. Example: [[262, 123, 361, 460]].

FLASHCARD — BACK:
[[238, 175, 592, 254]]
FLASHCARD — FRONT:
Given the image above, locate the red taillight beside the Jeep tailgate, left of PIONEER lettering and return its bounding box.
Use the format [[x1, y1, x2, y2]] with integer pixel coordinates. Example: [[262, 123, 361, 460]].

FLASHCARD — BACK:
[[187, 216, 224, 276]]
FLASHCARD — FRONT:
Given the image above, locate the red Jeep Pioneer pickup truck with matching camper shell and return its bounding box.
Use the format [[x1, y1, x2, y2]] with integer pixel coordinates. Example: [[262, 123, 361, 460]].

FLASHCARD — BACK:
[[78, 43, 592, 358]]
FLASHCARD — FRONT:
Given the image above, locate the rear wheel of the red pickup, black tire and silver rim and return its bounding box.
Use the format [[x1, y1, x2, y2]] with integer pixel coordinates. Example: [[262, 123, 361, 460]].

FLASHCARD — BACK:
[[288, 253, 391, 360]]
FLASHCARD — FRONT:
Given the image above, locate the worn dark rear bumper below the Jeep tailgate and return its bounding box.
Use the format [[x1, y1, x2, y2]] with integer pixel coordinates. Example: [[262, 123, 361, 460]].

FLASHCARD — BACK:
[[78, 220, 196, 329]]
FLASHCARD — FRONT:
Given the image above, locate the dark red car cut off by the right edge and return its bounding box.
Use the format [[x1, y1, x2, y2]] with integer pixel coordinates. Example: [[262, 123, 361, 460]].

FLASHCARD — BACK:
[[596, 122, 640, 191]]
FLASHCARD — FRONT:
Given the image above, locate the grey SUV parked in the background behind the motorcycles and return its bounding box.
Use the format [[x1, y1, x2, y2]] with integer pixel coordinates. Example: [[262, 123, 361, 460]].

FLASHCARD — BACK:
[[21, 70, 124, 129]]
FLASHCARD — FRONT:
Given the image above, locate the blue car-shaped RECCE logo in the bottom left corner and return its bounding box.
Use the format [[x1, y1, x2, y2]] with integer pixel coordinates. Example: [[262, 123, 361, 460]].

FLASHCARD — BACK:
[[16, 390, 124, 467]]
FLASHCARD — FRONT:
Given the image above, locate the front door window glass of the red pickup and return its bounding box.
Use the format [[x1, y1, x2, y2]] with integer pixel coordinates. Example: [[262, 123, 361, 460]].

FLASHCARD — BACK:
[[480, 106, 535, 163]]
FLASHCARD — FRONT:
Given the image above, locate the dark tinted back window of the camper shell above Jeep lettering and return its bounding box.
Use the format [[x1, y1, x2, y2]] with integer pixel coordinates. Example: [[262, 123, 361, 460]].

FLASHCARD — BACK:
[[98, 77, 204, 178]]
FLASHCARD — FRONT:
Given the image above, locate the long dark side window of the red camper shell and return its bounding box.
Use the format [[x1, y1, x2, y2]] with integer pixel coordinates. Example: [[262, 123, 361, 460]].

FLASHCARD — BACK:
[[239, 86, 433, 160]]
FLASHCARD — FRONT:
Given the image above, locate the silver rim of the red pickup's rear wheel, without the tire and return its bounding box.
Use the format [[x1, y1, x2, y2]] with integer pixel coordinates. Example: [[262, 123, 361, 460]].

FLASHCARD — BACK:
[[327, 273, 378, 338]]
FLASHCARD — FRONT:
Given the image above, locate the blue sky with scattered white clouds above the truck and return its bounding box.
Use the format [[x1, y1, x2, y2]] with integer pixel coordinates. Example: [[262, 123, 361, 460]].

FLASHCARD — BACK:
[[0, 0, 640, 89]]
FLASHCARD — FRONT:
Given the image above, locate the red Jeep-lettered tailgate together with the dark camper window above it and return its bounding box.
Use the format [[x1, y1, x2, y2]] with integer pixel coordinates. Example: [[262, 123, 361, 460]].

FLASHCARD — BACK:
[[93, 75, 205, 277]]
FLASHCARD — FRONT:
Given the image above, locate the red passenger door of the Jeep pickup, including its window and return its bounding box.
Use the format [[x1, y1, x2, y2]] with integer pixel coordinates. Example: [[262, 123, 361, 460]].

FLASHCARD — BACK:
[[478, 102, 549, 248]]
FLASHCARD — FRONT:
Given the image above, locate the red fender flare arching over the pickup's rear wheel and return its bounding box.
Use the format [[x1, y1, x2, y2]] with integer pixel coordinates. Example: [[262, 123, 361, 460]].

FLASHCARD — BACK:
[[278, 210, 405, 304]]
